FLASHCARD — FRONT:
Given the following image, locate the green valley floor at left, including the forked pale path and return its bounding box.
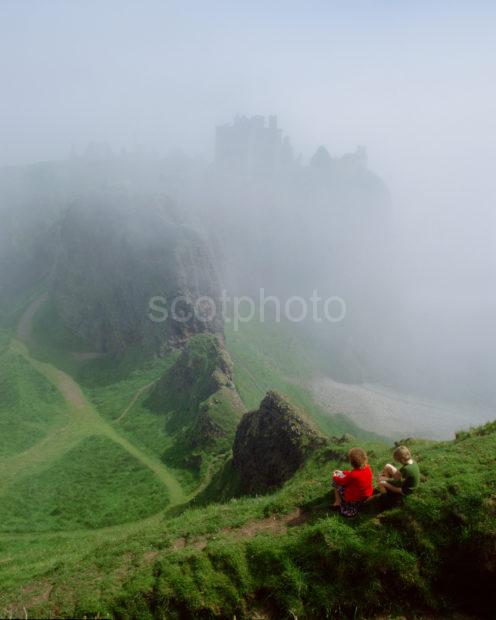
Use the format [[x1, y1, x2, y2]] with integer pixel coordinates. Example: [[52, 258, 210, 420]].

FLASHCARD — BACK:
[[0, 298, 186, 532]]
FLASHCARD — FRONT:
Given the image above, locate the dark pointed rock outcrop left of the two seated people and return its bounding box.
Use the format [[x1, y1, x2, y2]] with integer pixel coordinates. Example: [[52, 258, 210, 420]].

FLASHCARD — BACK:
[[233, 392, 325, 493]]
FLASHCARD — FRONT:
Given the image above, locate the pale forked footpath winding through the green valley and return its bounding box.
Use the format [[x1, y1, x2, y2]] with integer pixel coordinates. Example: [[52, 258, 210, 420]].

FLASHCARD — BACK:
[[13, 294, 186, 507]]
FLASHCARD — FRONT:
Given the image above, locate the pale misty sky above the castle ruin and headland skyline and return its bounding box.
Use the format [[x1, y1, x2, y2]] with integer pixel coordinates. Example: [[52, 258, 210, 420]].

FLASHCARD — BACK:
[[0, 0, 496, 294]]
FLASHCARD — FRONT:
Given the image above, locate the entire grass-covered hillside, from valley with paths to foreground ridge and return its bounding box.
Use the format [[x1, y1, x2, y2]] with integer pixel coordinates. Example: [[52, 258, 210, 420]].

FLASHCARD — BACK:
[[0, 296, 496, 618]]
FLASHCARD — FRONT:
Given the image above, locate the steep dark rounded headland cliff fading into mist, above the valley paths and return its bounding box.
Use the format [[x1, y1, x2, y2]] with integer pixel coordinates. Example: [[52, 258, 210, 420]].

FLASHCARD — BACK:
[[51, 197, 222, 354]]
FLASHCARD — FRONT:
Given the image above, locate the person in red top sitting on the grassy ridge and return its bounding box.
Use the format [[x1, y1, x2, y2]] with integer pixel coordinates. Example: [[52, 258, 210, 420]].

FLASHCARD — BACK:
[[332, 448, 374, 517]]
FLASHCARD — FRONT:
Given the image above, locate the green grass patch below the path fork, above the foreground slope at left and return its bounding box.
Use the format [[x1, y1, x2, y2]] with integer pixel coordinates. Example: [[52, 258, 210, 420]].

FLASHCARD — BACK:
[[0, 435, 168, 532]]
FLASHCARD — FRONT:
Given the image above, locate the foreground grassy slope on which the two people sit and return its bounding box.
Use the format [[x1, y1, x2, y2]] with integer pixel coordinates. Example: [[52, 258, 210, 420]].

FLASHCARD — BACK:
[[0, 424, 496, 618]]
